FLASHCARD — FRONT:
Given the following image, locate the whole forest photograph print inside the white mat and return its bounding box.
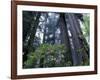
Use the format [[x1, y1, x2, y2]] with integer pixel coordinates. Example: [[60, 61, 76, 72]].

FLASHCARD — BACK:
[[23, 11, 90, 68]]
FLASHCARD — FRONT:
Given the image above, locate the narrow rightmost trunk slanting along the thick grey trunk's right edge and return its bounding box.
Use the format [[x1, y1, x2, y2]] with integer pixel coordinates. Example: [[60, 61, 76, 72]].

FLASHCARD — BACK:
[[74, 14, 89, 63]]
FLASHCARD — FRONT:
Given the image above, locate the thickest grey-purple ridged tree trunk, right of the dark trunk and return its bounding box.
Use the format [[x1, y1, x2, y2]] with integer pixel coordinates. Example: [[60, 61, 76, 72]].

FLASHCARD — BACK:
[[66, 13, 87, 65]]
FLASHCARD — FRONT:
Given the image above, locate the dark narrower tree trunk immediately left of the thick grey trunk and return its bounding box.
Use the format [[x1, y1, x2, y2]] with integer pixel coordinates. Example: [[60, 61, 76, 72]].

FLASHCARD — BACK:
[[59, 13, 72, 63]]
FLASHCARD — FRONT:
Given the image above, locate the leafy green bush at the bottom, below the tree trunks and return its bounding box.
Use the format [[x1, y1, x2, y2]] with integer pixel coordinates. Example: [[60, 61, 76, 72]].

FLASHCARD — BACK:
[[24, 44, 72, 68]]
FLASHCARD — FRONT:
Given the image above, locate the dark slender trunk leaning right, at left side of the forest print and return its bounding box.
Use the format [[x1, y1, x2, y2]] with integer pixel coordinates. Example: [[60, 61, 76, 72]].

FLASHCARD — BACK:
[[23, 13, 41, 62]]
